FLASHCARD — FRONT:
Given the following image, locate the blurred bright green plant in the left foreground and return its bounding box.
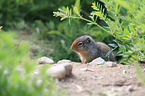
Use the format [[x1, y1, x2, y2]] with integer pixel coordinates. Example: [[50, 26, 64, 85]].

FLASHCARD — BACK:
[[0, 32, 57, 96]]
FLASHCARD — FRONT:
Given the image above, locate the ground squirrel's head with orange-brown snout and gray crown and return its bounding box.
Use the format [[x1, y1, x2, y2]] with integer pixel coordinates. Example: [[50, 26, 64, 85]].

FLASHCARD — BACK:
[[70, 35, 95, 53]]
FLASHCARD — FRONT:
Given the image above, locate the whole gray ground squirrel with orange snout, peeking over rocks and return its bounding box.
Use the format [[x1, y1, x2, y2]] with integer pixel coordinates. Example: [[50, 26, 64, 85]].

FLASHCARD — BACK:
[[70, 35, 115, 63]]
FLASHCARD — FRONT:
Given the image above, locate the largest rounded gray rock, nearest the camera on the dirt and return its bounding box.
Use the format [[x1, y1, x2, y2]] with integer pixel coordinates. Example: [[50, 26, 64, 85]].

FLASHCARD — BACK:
[[47, 63, 72, 79]]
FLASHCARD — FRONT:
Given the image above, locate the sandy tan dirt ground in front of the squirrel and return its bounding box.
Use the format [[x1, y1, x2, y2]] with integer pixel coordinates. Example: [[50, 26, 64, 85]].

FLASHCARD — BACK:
[[56, 62, 145, 96]]
